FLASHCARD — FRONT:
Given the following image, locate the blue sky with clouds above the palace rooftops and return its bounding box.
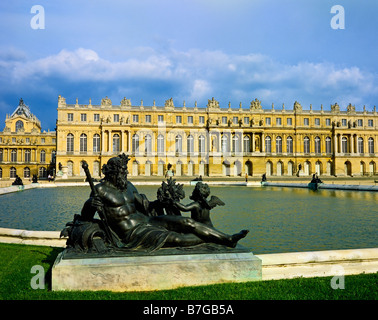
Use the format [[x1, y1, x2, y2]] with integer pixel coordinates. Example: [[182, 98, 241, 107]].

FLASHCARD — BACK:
[[0, 0, 378, 130]]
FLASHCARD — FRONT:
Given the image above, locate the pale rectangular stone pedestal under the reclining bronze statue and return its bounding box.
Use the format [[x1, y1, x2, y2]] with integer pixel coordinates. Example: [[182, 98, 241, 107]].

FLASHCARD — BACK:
[[52, 246, 262, 291]]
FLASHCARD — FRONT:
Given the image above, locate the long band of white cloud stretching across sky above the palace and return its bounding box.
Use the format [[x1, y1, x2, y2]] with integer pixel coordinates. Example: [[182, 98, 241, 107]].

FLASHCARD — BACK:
[[0, 48, 378, 107]]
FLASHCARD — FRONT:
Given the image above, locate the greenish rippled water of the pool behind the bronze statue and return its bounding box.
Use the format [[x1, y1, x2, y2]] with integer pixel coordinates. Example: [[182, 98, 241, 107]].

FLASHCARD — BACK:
[[0, 186, 378, 254]]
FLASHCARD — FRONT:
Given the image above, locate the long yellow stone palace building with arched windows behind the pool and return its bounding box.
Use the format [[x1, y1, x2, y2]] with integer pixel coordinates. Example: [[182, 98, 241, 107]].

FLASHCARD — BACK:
[[54, 96, 378, 177]]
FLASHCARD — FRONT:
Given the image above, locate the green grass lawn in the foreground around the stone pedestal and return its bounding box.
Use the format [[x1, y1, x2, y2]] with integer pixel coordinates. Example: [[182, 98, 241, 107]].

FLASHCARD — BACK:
[[0, 244, 378, 300]]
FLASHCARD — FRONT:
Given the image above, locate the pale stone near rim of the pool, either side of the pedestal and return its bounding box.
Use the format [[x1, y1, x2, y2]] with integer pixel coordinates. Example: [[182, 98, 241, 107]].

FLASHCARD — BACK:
[[0, 228, 378, 280]]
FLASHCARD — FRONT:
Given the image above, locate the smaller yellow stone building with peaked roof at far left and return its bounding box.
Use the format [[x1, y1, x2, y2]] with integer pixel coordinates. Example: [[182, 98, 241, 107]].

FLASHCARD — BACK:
[[0, 99, 56, 180]]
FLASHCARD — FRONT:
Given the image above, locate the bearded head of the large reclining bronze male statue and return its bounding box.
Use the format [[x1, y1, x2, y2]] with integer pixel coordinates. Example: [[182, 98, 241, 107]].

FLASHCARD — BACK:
[[101, 153, 130, 189]]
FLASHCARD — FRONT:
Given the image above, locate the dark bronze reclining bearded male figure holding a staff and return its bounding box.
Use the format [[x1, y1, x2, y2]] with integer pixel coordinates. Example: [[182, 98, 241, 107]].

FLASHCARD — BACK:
[[61, 154, 248, 252]]
